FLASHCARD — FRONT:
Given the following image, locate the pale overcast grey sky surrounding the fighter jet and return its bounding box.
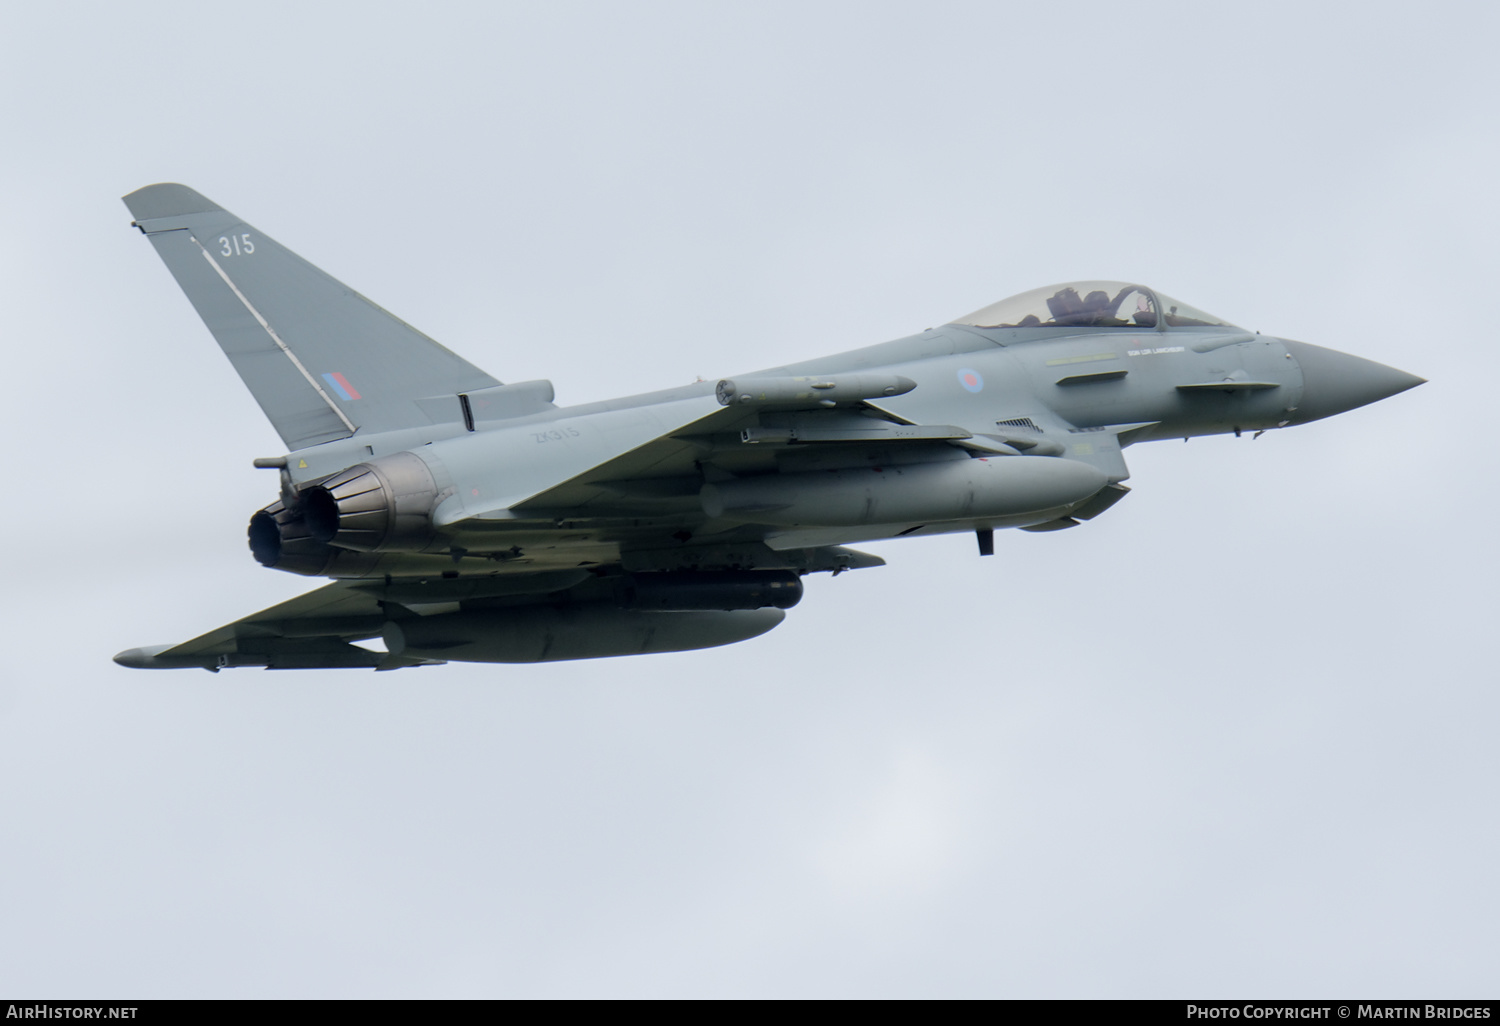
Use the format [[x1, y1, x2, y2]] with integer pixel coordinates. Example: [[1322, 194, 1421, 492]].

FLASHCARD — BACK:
[[0, 0, 1500, 998]]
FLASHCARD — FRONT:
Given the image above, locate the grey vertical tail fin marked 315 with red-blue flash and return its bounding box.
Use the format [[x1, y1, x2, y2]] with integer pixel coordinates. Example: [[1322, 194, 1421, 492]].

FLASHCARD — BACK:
[[125, 185, 500, 450]]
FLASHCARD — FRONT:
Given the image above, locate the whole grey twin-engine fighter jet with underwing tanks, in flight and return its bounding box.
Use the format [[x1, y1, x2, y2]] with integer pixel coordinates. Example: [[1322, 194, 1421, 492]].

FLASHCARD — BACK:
[[116, 185, 1422, 669]]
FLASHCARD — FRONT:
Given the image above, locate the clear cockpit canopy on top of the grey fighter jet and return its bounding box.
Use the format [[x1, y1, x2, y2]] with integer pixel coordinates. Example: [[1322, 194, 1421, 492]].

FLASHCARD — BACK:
[[953, 282, 1233, 332]]
